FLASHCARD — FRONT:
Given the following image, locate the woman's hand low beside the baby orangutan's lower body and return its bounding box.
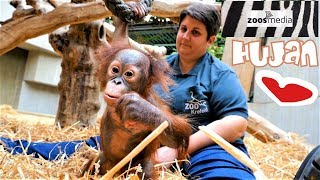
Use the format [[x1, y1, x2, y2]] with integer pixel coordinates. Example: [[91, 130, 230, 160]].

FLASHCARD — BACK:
[[156, 146, 178, 168]]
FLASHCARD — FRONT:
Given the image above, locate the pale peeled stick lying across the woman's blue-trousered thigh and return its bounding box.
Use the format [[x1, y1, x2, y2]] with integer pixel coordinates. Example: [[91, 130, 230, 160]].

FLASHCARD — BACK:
[[199, 126, 266, 180]]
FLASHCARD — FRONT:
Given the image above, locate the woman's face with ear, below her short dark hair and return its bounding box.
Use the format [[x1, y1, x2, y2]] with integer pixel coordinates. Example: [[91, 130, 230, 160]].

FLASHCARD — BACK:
[[176, 16, 215, 60]]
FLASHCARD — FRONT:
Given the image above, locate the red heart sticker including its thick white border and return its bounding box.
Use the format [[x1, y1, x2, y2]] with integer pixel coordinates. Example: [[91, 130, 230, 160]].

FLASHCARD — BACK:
[[256, 70, 318, 106]]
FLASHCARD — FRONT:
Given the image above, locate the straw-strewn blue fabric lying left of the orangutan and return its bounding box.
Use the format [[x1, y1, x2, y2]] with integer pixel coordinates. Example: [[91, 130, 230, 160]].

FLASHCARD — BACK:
[[0, 136, 100, 161]]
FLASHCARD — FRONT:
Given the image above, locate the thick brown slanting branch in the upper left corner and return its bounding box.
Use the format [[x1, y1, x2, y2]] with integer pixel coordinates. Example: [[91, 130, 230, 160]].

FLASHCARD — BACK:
[[0, 1, 111, 56]]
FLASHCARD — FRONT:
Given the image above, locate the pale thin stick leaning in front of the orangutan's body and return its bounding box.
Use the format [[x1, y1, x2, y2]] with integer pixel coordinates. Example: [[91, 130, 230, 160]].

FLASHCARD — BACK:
[[101, 121, 169, 180]]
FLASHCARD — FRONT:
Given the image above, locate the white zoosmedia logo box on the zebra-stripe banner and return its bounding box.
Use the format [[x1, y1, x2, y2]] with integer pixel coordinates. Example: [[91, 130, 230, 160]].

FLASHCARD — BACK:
[[247, 10, 293, 27]]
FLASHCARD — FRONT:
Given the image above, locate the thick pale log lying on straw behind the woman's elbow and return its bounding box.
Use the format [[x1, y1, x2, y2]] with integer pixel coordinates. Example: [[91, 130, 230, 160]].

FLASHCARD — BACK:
[[247, 109, 293, 143]]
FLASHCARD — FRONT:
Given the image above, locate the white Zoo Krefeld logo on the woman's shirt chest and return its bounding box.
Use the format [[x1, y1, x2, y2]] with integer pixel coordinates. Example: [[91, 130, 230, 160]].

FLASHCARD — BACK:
[[185, 91, 209, 114]]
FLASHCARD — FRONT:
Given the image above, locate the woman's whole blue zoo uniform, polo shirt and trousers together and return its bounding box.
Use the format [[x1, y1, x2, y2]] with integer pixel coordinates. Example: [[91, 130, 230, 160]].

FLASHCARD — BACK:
[[155, 53, 255, 179]]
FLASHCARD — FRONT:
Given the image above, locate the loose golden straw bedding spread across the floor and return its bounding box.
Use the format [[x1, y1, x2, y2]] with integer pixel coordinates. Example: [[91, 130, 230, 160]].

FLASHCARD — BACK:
[[0, 105, 310, 179]]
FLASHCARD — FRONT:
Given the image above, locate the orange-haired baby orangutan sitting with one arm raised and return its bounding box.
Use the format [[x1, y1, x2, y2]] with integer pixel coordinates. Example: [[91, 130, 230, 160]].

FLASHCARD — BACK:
[[85, 11, 192, 179]]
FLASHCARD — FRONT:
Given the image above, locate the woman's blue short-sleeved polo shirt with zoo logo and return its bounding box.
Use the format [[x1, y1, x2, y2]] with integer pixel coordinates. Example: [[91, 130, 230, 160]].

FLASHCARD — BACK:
[[156, 53, 248, 143]]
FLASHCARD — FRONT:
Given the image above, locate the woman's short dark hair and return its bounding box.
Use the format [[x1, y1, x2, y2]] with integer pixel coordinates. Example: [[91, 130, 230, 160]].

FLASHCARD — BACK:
[[179, 3, 221, 39]]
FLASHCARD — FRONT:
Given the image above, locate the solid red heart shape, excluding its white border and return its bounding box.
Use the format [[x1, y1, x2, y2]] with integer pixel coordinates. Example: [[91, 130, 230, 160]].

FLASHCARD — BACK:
[[262, 77, 312, 102]]
